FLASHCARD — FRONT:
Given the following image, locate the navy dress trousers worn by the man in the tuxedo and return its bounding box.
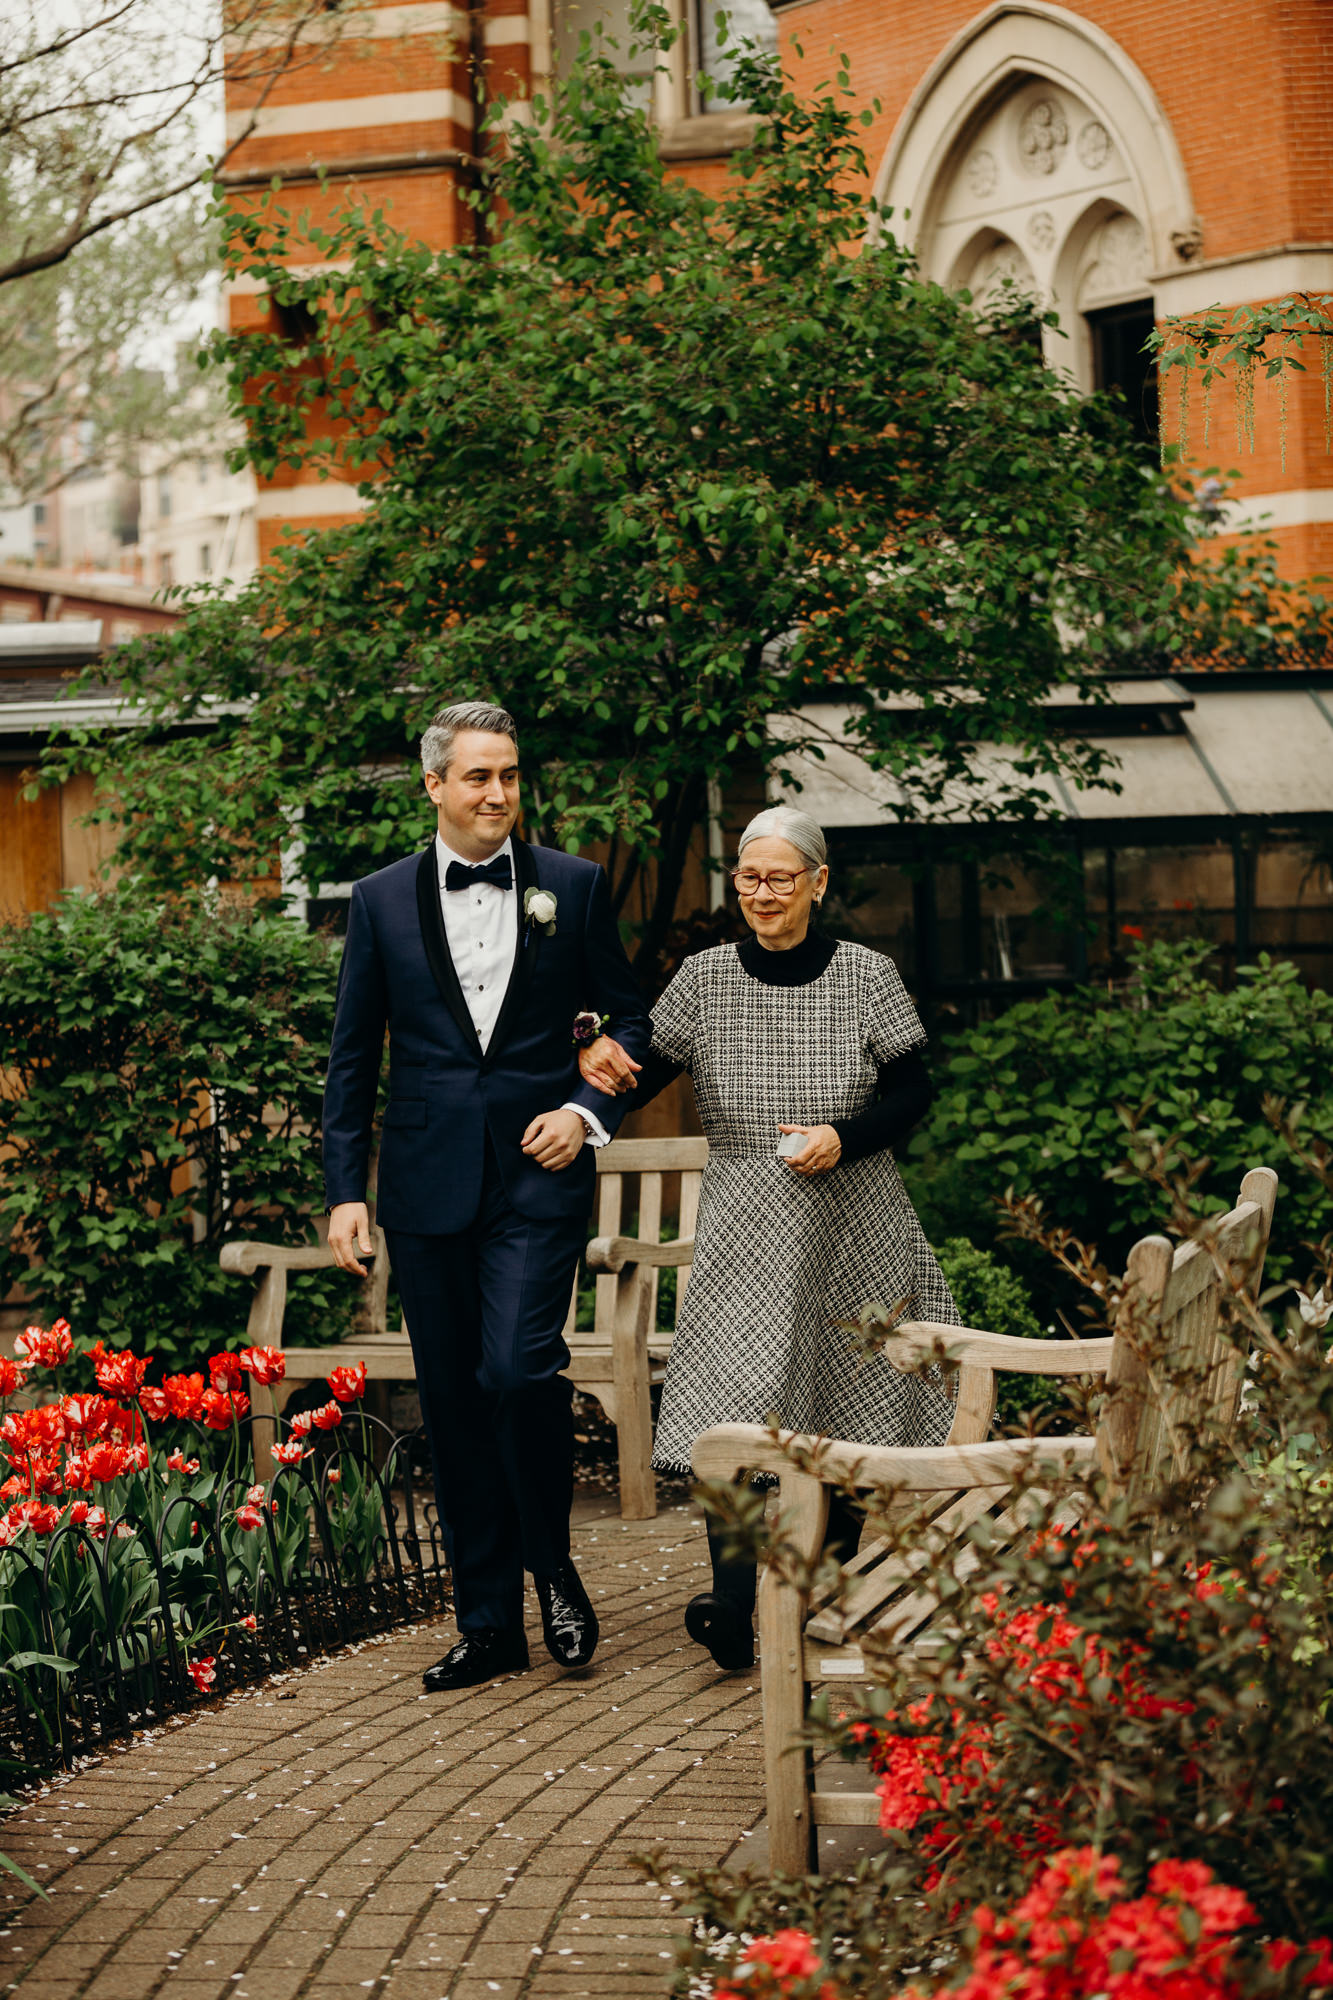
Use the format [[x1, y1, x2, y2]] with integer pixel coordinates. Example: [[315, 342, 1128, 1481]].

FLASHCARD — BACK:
[[384, 1144, 586, 1632]]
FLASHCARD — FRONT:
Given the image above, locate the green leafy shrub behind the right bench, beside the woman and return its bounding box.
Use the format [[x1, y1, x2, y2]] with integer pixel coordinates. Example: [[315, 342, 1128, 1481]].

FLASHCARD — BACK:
[[905, 942, 1333, 1320]]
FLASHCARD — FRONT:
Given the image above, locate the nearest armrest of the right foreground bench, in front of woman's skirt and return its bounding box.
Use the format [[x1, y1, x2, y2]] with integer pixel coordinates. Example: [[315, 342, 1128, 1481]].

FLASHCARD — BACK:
[[695, 1424, 1097, 1494]]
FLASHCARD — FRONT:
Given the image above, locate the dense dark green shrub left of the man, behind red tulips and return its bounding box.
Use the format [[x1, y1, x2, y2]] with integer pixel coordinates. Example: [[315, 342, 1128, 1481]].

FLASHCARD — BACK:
[[0, 884, 350, 1370]]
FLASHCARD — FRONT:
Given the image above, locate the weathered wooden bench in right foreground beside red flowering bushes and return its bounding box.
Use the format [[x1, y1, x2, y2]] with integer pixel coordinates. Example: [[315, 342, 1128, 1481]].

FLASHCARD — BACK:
[[695, 1168, 1277, 1874]]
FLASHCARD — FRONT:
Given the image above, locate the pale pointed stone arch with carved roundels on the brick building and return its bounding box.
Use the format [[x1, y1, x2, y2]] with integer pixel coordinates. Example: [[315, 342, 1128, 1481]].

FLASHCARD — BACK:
[[875, 0, 1201, 282]]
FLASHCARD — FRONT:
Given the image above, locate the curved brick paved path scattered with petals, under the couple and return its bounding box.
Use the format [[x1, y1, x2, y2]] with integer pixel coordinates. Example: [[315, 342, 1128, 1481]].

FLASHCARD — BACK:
[[0, 1502, 763, 2000]]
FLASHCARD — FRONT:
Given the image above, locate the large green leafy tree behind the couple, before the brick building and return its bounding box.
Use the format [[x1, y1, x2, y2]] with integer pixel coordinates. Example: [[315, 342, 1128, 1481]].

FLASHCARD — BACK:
[[46, 17, 1232, 972]]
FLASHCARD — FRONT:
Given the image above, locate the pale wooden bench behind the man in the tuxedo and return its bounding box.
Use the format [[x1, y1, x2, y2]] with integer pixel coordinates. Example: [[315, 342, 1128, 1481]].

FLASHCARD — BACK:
[[220, 1138, 709, 1520]]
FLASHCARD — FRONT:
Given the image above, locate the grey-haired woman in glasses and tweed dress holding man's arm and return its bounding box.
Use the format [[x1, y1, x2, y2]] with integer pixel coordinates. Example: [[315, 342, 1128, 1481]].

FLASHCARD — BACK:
[[580, 806, 959, 1670]]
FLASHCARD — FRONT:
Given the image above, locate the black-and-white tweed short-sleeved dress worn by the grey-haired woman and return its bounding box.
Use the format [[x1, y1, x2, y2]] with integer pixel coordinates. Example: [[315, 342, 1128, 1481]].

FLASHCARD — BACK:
[[652, 928, 948, 1472]]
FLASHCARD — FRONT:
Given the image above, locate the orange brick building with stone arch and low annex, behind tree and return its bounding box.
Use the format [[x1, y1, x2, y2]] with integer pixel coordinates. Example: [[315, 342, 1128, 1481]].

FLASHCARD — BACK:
[[220, 0, 1333, 1008]]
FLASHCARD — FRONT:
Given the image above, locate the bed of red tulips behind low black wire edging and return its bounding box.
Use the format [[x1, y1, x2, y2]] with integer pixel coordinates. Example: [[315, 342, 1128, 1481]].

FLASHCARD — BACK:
[[0, 1320, 446, 1768]]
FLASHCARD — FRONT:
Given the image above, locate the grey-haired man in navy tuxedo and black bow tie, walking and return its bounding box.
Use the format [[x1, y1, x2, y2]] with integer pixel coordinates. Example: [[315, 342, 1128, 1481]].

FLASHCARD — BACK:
[[324, 702, 652, 1692]]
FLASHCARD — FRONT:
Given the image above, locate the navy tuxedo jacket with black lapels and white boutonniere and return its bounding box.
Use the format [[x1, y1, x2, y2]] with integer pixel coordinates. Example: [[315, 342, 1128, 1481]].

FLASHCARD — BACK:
[[324, 834, 652, 1236]]
